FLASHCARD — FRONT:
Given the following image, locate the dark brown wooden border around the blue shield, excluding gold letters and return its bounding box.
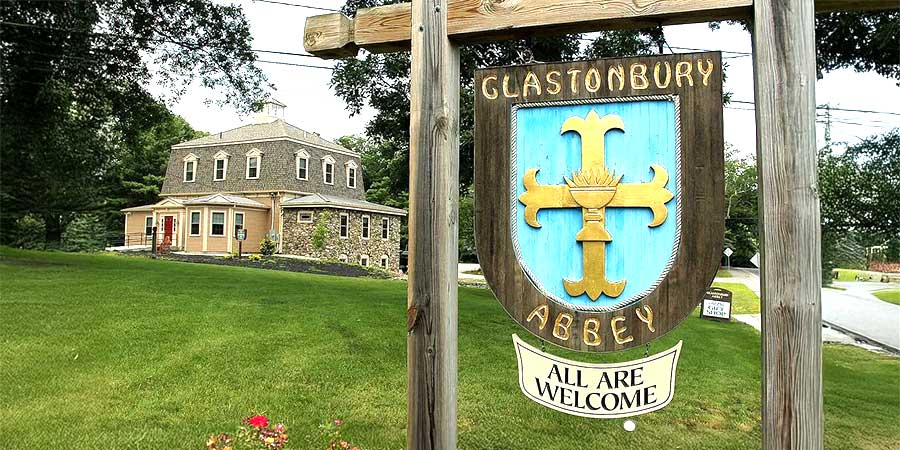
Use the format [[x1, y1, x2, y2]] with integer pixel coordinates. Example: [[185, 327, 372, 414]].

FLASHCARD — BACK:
[[475, 52, 724, 352]]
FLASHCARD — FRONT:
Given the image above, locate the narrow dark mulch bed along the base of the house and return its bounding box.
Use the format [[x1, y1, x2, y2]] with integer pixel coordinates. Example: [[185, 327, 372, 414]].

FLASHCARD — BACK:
[[125, 252, 391, 278]]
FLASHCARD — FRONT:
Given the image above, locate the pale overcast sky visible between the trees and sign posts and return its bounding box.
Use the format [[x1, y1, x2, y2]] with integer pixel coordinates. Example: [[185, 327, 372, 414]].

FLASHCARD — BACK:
[[162, 0, 900, 155]]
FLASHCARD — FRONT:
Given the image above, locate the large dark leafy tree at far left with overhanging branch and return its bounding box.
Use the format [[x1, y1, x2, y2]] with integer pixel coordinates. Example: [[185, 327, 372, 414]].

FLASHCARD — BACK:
[[0, 0, 265, 245]]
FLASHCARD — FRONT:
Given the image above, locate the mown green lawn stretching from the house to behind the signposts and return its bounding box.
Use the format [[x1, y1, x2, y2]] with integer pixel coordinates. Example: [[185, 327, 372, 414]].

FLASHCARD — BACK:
[[0, 249, 900, 450]]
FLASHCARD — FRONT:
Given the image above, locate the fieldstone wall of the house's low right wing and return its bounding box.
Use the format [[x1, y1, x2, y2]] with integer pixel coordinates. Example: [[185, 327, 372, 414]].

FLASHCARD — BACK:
[[282, 208, 400, 272]]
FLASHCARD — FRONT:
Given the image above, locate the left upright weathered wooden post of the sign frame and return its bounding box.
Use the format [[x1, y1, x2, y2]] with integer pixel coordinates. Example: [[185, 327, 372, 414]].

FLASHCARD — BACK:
[[407, 0, 459, 450]]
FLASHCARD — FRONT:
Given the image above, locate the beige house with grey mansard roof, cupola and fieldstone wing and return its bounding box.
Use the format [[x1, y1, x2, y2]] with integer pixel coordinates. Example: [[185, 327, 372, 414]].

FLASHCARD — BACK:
[[122, 101, 406, 270]]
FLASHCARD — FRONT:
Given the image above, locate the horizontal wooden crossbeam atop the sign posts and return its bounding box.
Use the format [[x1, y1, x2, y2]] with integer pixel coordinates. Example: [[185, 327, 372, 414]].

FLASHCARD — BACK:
[[303, 0, 900, 59]]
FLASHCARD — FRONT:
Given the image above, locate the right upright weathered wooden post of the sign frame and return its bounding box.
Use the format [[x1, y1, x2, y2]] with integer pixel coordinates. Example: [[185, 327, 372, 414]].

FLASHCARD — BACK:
[[753, 0, 823, 450]]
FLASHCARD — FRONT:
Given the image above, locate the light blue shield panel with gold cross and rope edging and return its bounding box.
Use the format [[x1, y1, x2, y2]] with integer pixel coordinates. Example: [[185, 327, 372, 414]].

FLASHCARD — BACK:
[[510, 96, 682, 311]]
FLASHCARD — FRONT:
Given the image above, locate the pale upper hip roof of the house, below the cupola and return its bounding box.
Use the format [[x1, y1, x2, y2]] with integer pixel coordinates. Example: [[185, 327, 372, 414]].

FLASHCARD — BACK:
[[172, 119, 359, 156]]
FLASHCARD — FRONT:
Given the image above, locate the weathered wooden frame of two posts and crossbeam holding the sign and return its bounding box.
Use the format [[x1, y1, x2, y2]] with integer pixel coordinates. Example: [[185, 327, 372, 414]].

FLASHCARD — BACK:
[[303, 0, 897, 450]]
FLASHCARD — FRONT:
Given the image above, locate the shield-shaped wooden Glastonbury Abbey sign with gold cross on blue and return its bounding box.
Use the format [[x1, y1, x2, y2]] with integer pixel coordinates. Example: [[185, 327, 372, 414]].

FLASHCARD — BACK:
[[475, 52, 724, 352]]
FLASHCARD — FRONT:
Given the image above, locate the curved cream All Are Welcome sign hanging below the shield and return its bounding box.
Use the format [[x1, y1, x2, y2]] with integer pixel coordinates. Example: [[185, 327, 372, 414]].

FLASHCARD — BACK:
[[513, 334, 681, 419]]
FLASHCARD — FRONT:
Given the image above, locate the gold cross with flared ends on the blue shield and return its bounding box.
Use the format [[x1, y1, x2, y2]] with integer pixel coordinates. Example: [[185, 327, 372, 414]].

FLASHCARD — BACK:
[[519, 110, 673, 301]]
